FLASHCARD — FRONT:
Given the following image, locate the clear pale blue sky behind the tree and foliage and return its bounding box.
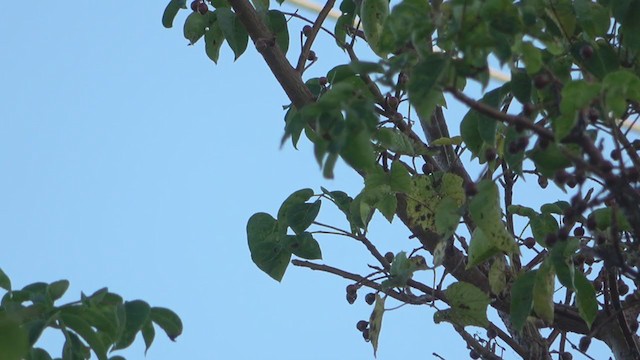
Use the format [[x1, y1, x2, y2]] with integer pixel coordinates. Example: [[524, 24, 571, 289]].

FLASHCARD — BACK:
[[0, 1, 608, 360]]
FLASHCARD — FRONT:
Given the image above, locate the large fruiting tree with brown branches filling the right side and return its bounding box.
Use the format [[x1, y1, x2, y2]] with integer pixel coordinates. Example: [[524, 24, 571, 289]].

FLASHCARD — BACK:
[[162, 0, 640, 359]]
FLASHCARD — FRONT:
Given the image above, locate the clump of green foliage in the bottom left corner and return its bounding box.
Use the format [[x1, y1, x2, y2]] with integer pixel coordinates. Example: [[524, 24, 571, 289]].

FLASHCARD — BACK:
[[0, 269, 182, 360]]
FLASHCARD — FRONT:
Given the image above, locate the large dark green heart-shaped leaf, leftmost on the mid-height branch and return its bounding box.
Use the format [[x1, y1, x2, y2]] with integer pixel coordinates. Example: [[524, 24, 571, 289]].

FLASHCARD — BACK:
[[247, 213, 291, 281]]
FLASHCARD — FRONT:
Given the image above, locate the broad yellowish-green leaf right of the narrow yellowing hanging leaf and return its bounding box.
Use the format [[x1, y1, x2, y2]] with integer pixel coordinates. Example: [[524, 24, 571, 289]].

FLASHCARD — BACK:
[[433, 281, 491, 327]]
